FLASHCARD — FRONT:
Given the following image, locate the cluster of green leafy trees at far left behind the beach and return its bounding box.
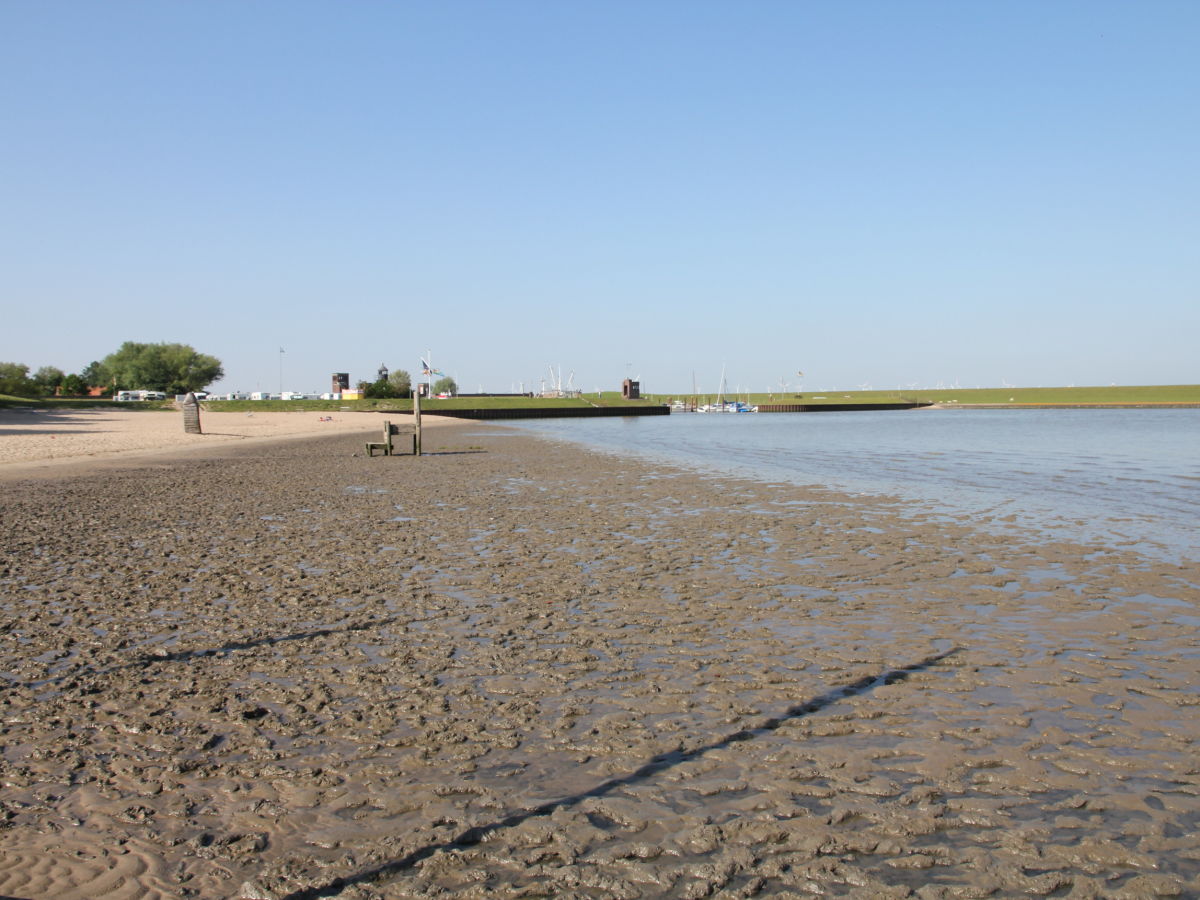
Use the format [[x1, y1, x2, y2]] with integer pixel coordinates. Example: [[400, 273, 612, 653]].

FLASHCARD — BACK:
[[0, 341, 224, 397]]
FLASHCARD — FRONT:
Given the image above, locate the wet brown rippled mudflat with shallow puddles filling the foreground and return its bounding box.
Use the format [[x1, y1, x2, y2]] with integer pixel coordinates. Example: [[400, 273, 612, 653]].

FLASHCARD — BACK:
[[0, 425, 1200, 900]]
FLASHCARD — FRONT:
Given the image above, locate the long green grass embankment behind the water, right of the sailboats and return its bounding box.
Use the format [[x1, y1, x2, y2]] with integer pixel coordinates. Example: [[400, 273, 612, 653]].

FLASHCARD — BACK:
[[654, 384, 1200, 407]]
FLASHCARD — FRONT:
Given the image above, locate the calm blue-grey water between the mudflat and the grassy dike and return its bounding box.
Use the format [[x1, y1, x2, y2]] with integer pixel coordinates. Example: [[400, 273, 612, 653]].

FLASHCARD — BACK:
[[522, 409, 1200, 559]]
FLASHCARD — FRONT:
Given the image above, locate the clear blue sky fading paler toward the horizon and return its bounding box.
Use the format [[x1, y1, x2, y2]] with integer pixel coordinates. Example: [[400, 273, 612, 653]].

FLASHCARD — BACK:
[[0, 0, 1200, 392]]
